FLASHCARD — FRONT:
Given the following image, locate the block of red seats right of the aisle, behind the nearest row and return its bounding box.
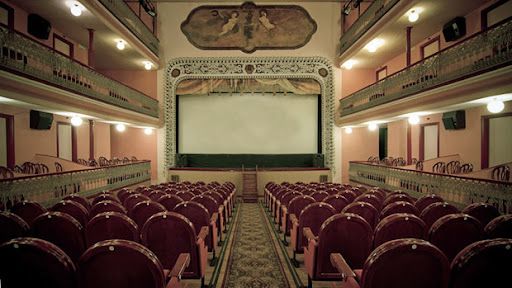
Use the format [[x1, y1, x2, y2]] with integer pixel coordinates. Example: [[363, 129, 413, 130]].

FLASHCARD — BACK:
[[265, 183, 512, 285]]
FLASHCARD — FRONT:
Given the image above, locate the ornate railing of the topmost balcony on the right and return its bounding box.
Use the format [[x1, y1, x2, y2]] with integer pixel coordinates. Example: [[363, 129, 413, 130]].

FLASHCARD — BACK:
[[339, 0, 399, 56]]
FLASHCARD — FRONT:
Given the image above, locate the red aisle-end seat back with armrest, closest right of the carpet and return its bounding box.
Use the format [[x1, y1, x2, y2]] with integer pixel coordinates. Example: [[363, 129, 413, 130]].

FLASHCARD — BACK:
[[316, 213, 373, 278]]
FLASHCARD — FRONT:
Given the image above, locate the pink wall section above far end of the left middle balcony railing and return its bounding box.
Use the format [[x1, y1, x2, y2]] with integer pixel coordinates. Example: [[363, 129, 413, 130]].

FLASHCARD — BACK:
[[100, 70, 157, 99]]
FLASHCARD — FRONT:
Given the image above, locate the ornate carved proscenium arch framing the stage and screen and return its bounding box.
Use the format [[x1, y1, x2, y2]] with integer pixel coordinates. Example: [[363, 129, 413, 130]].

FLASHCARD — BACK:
[[163, 57, 335, 173]]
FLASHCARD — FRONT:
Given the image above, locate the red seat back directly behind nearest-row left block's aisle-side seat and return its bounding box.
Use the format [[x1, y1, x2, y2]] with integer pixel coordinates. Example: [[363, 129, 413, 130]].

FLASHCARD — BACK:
[[85, 212, 139, 247]]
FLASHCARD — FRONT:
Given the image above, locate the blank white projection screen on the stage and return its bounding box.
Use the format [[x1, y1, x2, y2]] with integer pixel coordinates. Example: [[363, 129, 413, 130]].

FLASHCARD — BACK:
[[177, 93, 320, 154]]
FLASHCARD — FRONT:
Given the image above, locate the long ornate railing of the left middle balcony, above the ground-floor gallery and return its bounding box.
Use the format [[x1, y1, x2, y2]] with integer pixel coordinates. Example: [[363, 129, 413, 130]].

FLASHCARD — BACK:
[[0, 26, 158, 117]]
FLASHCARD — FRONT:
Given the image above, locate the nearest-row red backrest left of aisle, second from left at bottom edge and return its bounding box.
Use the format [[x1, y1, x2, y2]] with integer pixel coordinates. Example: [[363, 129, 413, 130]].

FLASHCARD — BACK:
[[78, 240, 165, 288]]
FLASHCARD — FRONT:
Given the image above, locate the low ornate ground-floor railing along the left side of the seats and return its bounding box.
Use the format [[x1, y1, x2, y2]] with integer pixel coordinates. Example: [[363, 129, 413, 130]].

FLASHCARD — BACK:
[[0, 161, 151, 206]]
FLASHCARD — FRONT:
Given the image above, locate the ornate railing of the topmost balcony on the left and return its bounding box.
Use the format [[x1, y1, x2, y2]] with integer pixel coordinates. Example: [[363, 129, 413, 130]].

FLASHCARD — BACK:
[[98, 0, 159, 56]]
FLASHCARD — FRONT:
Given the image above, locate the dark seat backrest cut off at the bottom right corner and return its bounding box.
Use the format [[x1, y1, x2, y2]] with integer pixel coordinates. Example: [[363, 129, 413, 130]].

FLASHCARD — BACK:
[[450, 238, 512, 288]]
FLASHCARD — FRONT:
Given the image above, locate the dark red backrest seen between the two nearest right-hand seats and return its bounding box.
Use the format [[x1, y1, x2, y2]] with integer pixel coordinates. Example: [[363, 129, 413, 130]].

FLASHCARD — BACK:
[[429, 213, 484, 261]]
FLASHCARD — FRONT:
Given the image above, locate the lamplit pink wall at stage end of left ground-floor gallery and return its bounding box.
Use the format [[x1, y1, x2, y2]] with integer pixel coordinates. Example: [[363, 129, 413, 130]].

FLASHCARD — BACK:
[[110, 126, 157, 179]]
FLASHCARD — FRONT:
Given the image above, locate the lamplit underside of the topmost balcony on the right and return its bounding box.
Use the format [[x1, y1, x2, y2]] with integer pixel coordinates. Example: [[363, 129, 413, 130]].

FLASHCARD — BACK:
[[342, 0, 488, 69]]
